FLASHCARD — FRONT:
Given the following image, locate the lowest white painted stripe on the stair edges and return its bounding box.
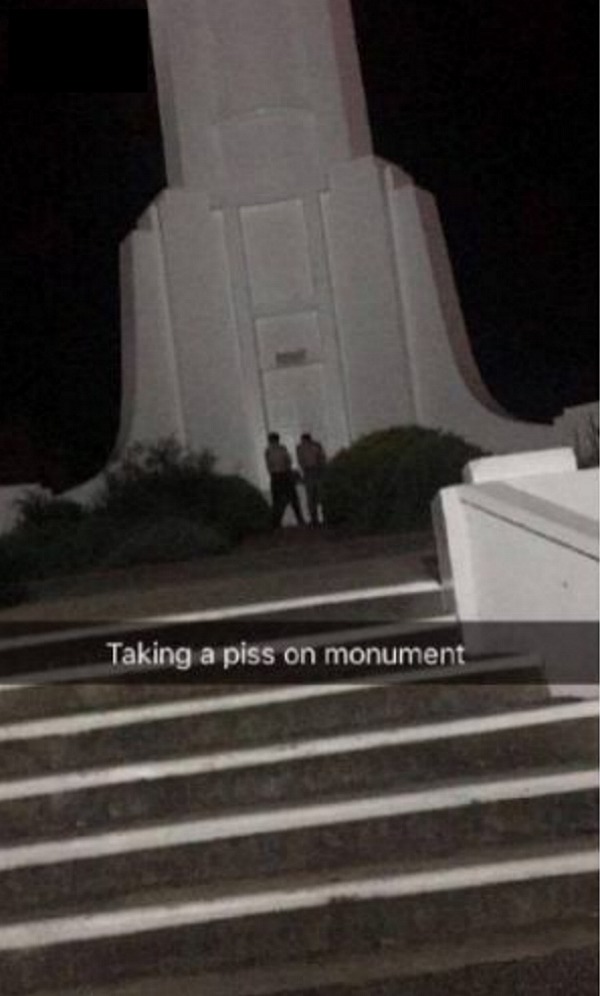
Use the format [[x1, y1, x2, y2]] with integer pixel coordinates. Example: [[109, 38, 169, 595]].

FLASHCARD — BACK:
[[0, 850, 600, 951]]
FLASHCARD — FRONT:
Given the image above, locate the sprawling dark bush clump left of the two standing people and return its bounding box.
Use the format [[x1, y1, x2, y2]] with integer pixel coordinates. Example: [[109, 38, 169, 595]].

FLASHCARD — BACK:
[[0, 440, 270, 605]]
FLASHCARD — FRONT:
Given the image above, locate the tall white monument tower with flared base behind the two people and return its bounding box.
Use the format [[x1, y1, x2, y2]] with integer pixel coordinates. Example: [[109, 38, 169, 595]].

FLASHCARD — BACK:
[[119, 0, 553, 484]]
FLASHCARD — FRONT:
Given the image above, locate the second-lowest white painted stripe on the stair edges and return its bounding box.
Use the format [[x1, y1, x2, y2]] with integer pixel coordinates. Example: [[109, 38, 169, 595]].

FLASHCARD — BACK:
[[0, 770, 598, 872]]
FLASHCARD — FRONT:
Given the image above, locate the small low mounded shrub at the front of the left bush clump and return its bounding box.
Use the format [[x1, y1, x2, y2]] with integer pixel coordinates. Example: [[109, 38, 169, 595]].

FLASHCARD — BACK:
[[102, 517, 229, 567]]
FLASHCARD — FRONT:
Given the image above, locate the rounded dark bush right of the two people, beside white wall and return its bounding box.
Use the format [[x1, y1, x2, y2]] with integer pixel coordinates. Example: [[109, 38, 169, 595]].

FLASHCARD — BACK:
[[324, 426, 482, 532]]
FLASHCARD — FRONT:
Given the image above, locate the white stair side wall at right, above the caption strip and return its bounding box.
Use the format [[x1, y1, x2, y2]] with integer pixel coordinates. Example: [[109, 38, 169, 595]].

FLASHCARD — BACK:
[[434, 462, 599, 621]]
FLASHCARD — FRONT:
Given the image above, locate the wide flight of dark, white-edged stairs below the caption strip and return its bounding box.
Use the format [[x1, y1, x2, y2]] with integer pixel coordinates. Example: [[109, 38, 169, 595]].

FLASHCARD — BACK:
[[0, 640, 598, 996]]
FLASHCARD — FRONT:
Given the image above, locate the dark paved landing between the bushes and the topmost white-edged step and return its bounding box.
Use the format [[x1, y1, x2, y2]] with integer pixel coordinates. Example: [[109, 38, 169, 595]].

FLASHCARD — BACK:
[[0, 528, 435, 622]]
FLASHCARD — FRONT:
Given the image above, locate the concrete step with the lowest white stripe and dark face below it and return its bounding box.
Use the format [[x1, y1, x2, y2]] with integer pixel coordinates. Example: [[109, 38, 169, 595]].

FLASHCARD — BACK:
[[0, 846, 598, 996]]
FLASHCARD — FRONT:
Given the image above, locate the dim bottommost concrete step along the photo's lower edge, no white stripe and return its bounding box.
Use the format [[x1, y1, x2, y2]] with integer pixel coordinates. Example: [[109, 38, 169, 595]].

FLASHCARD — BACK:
[[21, 925, 598, 996]]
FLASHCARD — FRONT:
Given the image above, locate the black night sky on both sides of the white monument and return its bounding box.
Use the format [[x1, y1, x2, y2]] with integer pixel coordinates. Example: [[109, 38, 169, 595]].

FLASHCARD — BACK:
[[0, 0, 597, 484]]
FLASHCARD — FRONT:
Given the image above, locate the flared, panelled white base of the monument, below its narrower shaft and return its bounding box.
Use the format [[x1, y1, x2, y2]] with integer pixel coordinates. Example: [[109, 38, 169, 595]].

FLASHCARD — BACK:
[[119, 156, 554, 487]]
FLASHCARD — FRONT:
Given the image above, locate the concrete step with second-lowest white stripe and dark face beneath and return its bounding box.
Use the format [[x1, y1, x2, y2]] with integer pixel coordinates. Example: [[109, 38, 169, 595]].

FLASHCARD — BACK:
[[0, 769, 598, 920]]
